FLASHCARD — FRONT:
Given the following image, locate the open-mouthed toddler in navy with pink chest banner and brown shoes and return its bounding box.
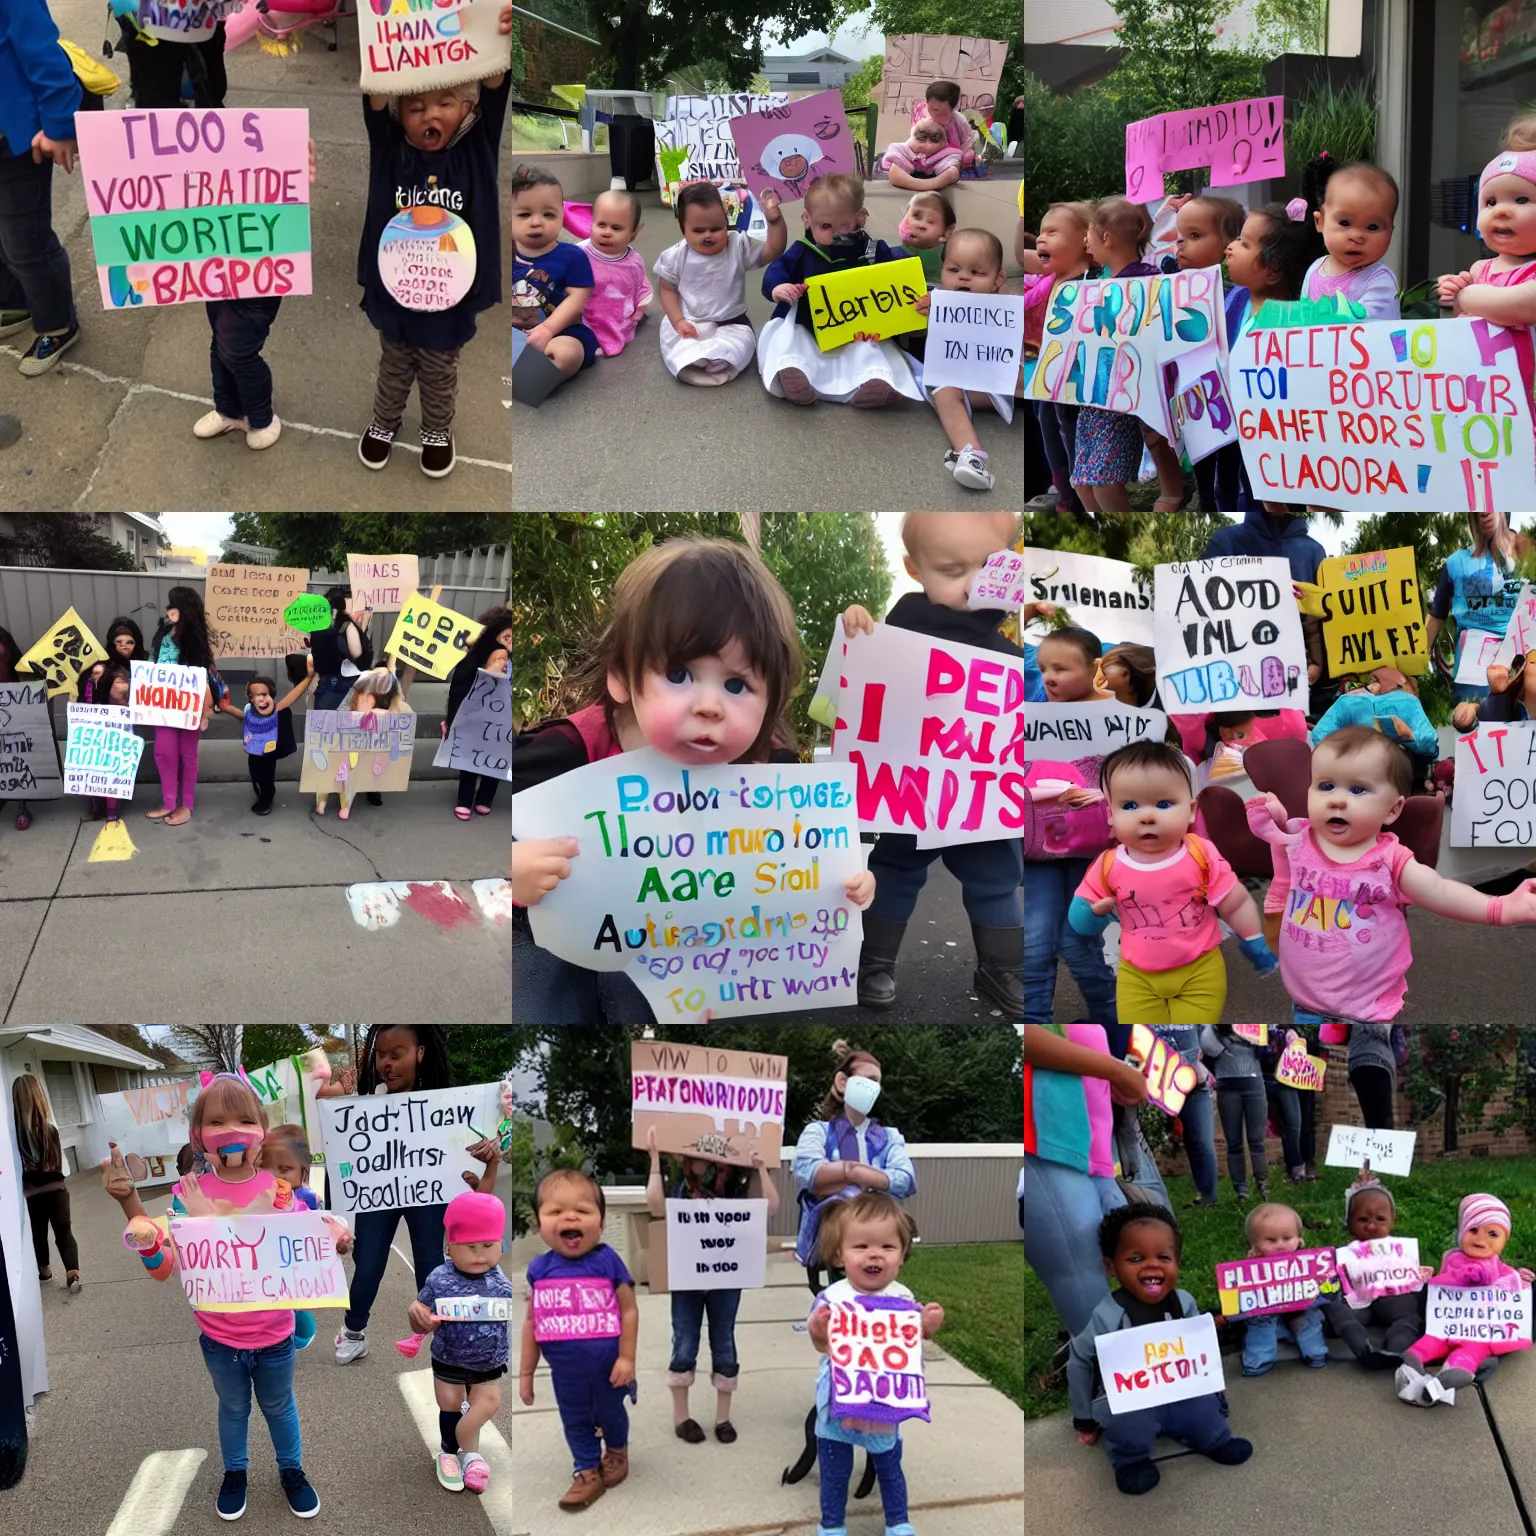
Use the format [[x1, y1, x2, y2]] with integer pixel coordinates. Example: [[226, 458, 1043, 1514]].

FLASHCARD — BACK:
[[518, 1169, 641, 1510]]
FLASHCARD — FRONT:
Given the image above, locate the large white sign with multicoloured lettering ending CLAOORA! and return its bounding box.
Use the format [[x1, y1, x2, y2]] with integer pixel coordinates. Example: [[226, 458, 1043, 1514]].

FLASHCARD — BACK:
[[1227, 319, 1536, 511]]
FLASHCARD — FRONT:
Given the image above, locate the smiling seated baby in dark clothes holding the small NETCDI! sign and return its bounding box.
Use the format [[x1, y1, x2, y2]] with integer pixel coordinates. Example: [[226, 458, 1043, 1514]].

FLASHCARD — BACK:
[[1066, 1204, 1253, 1493]]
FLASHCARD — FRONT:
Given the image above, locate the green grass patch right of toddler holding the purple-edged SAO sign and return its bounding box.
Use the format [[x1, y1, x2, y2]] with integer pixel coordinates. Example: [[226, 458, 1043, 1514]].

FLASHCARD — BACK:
[[902, 1243, 1032, 1407]]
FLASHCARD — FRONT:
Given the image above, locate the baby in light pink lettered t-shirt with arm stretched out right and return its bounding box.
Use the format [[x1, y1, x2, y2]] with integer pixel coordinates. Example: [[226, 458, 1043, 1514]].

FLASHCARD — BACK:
[[1246, 725, 1536, 1023]]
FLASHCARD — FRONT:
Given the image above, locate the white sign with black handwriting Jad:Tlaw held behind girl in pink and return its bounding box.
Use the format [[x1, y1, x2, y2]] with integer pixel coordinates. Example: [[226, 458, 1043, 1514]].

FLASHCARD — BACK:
[[316, 1083, 496, 1215]]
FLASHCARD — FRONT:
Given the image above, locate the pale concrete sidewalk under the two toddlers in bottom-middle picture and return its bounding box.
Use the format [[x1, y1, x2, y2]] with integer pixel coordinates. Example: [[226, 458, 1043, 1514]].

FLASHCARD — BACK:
[[507, 1253, 1023, 1536]]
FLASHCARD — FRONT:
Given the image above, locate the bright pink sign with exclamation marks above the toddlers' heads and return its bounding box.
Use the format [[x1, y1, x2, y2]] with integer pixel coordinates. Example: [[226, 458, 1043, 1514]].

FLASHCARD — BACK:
[[1126, 97, 1286, 203]]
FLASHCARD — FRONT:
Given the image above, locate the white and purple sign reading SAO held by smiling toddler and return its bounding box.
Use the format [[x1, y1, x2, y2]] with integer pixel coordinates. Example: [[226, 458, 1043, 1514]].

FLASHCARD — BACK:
[[826, 1293, 931, 1424]]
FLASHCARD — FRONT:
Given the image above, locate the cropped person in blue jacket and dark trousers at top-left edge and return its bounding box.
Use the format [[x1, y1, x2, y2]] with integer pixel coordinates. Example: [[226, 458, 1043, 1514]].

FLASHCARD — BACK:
[[0, 0, 80, 378]]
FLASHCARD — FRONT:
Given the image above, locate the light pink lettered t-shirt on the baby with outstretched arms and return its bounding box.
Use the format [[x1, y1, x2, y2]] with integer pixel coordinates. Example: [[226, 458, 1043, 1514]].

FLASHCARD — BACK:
[[1247, 800, 1413, 1023]]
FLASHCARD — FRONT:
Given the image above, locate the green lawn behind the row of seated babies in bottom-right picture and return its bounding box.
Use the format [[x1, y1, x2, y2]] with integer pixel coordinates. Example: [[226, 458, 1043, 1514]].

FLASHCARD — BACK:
[[1019, 1157, 1536, 1418]]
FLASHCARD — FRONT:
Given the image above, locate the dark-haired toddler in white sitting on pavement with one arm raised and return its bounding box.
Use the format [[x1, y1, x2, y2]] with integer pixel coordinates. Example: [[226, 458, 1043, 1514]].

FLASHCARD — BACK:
[[656, 181, 786, 384]]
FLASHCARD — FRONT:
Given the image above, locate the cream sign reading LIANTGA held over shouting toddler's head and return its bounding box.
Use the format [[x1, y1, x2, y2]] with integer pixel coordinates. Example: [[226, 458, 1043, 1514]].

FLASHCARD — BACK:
[[358, 0, 511, 95]]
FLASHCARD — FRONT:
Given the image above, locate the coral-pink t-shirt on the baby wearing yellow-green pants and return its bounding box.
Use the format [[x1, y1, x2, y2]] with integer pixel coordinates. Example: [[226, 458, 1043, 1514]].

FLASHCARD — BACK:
[[1077, 837, 1238, 971]]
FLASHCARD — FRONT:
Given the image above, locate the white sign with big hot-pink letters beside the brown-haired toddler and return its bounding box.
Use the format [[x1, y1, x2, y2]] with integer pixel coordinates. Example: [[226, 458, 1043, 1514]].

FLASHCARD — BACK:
[[829, 624, 1034, 848]]
